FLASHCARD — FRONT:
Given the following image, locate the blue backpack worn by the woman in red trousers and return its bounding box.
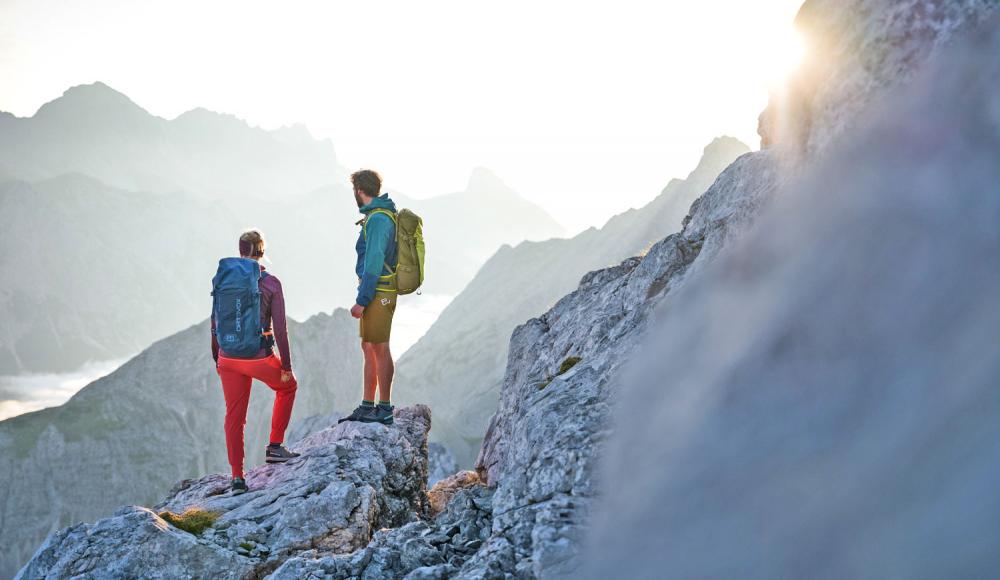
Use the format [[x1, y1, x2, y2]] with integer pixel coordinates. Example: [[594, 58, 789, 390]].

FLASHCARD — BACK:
[[212, 258, 267, 358]]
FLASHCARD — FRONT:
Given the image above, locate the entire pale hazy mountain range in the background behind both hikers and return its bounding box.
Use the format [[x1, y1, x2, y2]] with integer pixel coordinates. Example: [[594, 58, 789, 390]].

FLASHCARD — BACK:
[[0, 83, 563, 374]]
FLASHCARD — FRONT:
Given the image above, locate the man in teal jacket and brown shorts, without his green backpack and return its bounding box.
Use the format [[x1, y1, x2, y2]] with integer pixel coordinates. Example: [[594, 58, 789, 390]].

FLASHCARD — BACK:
[[340, 169, 397, 425]]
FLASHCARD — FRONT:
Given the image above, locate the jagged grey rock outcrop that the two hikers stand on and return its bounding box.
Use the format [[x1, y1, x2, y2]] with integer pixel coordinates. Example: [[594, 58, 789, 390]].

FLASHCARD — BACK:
[[18, 406, 430, 579]]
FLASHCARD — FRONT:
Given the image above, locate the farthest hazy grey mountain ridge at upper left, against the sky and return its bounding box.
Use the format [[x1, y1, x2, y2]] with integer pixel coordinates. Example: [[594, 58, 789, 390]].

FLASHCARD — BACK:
[[0, 82, 350, 199]]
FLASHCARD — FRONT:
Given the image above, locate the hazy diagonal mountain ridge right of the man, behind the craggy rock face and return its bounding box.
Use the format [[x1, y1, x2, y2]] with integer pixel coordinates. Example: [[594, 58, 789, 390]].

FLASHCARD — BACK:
[[395, 137, 748, 467]]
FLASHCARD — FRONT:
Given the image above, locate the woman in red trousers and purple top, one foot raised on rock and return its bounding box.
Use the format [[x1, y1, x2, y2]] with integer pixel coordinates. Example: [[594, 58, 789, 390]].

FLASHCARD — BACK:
[[212, 230, 299, 494]]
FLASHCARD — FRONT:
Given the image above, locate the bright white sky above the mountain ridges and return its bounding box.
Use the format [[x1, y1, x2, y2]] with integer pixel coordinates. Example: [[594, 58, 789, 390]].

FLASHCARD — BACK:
[[0, 0, 801, 232]]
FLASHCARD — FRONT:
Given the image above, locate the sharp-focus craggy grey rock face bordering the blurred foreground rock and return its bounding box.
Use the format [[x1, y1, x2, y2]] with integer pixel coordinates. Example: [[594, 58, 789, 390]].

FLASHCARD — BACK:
[[468, 146, 778, 577]]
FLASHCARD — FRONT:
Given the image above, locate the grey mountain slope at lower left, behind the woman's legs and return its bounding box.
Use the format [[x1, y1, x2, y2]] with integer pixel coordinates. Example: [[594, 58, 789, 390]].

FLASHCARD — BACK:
[[0, 310, 361, 578]]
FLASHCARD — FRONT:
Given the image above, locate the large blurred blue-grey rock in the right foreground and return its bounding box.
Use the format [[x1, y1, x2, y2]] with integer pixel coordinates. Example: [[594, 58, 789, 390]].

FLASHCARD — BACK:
[[588, 11, 1000, 579]]
